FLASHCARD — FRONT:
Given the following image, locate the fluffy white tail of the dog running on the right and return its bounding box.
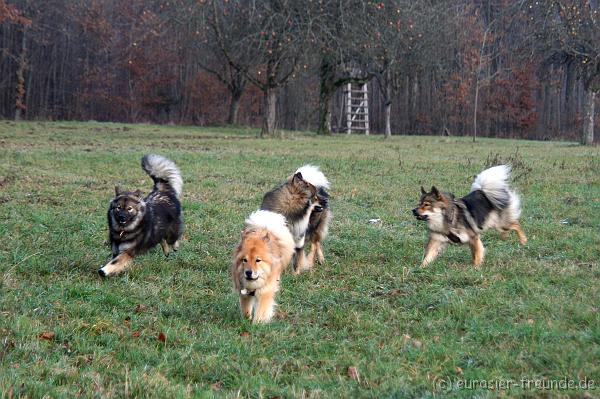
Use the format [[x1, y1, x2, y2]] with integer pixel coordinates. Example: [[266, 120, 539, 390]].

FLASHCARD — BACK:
[[471, 165, 521, 220]]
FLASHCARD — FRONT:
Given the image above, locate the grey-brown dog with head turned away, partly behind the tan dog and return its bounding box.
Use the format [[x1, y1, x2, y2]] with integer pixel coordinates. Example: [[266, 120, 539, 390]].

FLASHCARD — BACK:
[[260, 165, 331, 274]]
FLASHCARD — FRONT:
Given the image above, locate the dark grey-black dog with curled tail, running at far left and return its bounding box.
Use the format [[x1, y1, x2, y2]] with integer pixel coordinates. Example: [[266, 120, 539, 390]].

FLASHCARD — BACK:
[[98, 155, 184, 277]]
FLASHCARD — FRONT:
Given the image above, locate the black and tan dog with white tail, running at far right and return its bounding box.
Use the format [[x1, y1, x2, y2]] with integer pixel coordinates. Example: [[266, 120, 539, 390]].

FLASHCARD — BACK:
[[412, 165, 527, 267]]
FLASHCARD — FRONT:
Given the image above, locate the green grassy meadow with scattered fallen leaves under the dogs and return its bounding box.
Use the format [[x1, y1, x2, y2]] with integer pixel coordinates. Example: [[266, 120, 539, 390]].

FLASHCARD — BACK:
[[0, 122, 600, 398]]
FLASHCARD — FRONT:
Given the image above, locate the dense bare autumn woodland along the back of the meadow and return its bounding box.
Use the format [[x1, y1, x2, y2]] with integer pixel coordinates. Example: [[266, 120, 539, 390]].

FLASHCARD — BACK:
[[0, 0, 600, 144]]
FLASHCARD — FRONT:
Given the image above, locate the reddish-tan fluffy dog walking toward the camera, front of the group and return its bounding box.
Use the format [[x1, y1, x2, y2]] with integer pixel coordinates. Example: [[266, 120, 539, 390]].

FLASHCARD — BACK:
[[231, 210, 294, 323]]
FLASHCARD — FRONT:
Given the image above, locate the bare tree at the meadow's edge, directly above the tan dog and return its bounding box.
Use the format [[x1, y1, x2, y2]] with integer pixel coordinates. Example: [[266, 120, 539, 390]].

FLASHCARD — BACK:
[[210, 0, 309, 137]]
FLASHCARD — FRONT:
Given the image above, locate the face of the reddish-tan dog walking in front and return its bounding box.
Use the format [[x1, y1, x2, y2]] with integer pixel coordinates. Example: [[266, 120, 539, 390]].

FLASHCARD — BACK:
[[235, 230, 273, 289]]
